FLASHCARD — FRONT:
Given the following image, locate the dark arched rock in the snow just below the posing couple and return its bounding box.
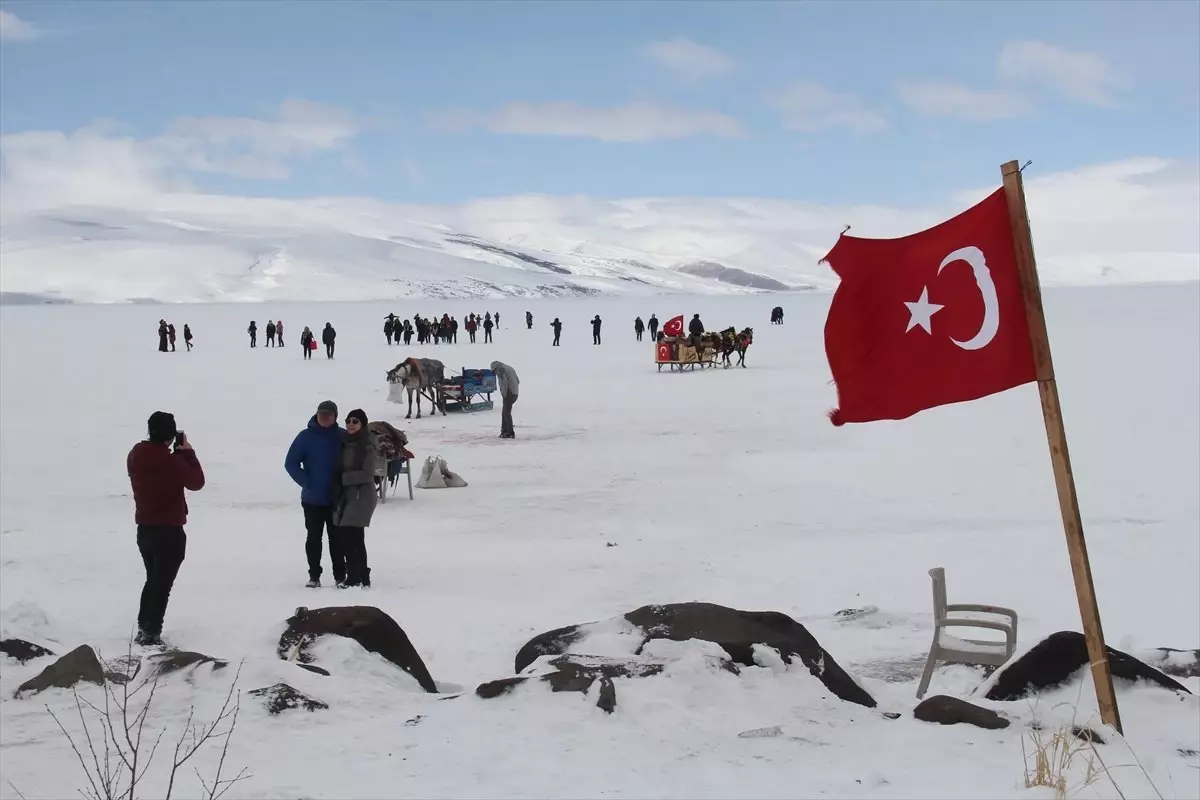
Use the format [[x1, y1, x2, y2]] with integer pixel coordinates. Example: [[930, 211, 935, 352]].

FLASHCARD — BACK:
[[276, 606, 438, 694]]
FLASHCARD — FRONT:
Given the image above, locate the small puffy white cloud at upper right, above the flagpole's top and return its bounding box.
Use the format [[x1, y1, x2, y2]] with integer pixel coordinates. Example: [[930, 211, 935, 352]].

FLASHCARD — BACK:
[[996, 41, 1128, 108]]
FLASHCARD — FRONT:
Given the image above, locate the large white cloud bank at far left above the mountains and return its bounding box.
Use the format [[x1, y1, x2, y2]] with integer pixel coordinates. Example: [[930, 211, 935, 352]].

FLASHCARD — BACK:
[[0, 100, 358, 205]]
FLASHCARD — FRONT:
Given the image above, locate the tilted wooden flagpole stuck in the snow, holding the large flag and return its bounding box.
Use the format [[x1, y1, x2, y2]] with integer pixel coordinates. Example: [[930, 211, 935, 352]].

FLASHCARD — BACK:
[[1000, 161, 1124, 734]]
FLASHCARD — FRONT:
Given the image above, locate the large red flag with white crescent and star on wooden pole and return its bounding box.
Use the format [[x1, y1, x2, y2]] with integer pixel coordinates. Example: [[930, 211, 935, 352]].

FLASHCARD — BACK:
[[822, 188, 1036, 425]]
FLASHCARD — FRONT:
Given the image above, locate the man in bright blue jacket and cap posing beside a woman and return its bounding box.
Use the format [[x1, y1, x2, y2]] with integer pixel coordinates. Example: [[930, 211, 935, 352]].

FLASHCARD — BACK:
[[283, 401, 346, 589]]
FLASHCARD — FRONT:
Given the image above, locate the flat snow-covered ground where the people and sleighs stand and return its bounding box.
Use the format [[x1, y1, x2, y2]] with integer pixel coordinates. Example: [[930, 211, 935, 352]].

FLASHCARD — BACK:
[[0, 289, 1200, 799]]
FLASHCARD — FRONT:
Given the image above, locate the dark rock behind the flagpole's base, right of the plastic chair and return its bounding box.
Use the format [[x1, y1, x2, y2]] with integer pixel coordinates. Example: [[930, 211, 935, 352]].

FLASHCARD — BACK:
[[985, 631, 1192, 700]]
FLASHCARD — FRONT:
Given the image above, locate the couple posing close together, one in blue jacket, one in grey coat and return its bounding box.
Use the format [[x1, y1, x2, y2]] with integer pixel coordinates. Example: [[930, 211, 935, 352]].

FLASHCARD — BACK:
[[283, 401, 380, 589]]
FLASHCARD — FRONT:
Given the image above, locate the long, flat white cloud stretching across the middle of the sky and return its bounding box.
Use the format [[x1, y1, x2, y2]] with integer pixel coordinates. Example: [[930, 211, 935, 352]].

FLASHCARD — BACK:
[[431, 101, 743, 143]]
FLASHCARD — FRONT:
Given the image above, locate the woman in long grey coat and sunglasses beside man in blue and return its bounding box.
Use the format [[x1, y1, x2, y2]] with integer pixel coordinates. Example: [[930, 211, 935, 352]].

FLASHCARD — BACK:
[[334, 408, 383, 589]]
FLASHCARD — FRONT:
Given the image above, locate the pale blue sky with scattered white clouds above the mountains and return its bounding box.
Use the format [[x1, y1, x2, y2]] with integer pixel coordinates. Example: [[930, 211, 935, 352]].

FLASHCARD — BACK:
[[0, 0, 1200, 206]]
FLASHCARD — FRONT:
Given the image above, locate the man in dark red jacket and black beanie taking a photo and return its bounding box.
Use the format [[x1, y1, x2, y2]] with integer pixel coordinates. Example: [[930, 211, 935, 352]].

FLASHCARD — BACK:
[[126, 411, 204, 646]]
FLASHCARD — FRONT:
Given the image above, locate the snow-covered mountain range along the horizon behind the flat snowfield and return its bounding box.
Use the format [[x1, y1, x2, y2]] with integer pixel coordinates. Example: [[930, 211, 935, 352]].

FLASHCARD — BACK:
[[0, 160, 1200, 302]]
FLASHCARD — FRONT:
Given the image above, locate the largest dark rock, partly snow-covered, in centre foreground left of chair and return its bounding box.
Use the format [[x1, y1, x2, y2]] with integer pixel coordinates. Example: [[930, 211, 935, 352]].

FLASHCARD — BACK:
[[516, 602, 876, 708]]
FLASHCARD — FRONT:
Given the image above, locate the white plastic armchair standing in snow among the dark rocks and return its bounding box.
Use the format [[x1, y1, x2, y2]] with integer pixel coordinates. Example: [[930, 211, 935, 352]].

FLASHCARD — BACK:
[[917, 566, 1016, 699]]
